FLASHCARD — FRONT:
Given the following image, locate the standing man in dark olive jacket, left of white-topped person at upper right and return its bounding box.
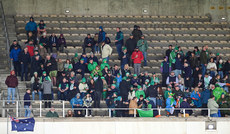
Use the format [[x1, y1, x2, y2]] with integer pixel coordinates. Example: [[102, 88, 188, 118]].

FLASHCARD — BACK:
[[200, 46, 208, 77]]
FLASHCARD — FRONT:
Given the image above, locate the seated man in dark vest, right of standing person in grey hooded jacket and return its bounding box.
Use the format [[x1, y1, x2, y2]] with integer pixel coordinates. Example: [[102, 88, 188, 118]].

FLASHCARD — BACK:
[[58, 78, 69, 100]]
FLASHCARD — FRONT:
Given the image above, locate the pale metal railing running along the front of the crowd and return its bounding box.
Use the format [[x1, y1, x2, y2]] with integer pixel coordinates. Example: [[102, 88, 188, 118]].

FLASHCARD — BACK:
[[0, 100, 230, 117]]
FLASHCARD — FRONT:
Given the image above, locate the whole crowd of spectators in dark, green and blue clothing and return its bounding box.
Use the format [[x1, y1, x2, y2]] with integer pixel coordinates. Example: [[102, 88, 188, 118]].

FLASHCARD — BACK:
[[5, 17, 230, 117]]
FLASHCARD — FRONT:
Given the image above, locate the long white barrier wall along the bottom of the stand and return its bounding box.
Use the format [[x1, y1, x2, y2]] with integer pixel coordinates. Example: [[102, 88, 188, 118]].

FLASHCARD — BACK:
[[0, 118, 230, 134]]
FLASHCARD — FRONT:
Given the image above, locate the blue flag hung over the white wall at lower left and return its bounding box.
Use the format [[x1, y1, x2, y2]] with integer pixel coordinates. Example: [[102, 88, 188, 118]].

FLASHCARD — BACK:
[[10, 117, 35, 132]]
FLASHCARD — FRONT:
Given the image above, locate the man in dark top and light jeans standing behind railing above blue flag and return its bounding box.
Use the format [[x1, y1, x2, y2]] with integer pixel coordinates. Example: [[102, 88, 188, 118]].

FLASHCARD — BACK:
[[24, 89, 31, 117]]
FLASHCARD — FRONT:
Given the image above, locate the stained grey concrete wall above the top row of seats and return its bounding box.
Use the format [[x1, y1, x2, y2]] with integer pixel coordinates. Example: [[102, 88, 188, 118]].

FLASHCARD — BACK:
[[2, 0, 230, 21]]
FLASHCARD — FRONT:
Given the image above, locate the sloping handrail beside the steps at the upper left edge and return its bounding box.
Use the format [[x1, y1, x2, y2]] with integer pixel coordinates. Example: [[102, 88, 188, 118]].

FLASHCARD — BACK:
[[0, 1, 12, 69]]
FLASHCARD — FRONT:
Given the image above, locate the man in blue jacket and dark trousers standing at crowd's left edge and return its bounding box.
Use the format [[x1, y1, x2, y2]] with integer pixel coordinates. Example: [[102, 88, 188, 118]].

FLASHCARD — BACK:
[[10, 46, 21, 76]]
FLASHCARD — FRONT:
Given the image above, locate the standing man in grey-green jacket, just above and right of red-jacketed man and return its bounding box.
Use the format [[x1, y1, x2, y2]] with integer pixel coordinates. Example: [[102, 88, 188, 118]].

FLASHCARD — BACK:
[[137, 35, 148, 66]]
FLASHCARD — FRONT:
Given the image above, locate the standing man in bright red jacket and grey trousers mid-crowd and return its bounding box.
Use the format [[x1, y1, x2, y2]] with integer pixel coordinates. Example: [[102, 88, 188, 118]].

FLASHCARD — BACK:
[[132, 47, 144, 75]]
